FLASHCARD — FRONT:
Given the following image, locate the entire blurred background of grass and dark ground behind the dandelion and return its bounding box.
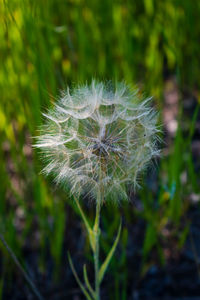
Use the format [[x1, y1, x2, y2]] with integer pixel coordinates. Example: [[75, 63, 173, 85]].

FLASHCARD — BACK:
[[0, 0, 200, 300]]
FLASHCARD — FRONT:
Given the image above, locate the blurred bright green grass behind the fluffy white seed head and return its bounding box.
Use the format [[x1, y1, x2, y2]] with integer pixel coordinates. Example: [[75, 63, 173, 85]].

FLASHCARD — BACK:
[[0, 0, 200, 299]]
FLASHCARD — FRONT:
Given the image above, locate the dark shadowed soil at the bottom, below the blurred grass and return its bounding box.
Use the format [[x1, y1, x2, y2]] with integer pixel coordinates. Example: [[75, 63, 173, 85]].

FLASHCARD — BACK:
[[3, 206, 200, 300]]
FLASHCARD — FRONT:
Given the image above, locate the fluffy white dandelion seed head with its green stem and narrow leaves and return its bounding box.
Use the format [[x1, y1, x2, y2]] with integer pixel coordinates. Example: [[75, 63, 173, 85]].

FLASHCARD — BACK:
[[35, 80, 159, 300]]
